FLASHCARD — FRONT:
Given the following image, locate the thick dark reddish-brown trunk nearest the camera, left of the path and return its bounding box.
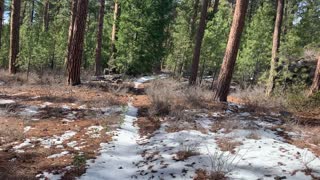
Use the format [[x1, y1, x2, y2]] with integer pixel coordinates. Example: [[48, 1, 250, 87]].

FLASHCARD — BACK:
[[68, 0, 89, 86]]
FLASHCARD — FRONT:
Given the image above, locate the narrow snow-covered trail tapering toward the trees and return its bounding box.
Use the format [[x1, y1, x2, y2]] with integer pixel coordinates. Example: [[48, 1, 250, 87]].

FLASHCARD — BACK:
[[80, 104, 142, 180]]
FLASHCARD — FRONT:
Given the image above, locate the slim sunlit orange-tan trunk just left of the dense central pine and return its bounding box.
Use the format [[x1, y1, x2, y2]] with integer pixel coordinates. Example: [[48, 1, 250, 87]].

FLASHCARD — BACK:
[[110, 0, 119, 64]]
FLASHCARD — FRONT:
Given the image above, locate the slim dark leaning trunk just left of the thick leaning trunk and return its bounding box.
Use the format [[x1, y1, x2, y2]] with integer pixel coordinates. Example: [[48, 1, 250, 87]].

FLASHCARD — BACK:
[[189, 0, 209, 85]]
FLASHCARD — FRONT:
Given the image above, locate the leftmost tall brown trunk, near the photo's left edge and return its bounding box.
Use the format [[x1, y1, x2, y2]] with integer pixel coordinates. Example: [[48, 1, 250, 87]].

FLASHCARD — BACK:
[[9, 0, 21, 74]]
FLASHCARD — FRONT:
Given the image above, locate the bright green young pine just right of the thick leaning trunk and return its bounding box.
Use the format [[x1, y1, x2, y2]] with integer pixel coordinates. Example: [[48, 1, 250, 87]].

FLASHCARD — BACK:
[[236, 2, 274, 83]]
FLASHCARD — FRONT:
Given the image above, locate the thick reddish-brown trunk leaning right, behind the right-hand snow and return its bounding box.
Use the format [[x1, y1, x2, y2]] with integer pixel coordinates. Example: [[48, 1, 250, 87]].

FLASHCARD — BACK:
[[215, 0, 249, 101]]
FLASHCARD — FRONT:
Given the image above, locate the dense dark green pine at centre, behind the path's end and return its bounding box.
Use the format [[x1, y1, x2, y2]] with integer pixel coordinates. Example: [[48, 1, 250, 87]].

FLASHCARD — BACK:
[[113, 0, 174, 75]]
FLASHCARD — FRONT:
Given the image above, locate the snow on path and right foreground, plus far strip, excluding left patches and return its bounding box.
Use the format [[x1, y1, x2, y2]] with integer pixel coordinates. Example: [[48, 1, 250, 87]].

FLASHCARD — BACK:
[[80, 77, 320, 180]]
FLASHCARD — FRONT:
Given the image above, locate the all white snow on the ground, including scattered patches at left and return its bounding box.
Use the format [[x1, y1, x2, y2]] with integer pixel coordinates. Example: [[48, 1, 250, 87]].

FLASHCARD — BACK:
[[5, 76, 320, 180]]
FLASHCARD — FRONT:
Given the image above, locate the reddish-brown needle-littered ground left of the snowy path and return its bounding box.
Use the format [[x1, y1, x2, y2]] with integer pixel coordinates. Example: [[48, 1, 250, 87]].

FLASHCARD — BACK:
[[0, 85, 128, 179]]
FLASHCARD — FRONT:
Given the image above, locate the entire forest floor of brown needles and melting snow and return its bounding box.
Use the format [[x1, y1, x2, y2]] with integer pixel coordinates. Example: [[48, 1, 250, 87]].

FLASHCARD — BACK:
[[0, 76, 320, 180]]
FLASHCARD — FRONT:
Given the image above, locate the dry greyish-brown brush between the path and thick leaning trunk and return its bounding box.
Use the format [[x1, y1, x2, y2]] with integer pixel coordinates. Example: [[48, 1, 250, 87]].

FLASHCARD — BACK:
[[146, 78, 221, 116]]
